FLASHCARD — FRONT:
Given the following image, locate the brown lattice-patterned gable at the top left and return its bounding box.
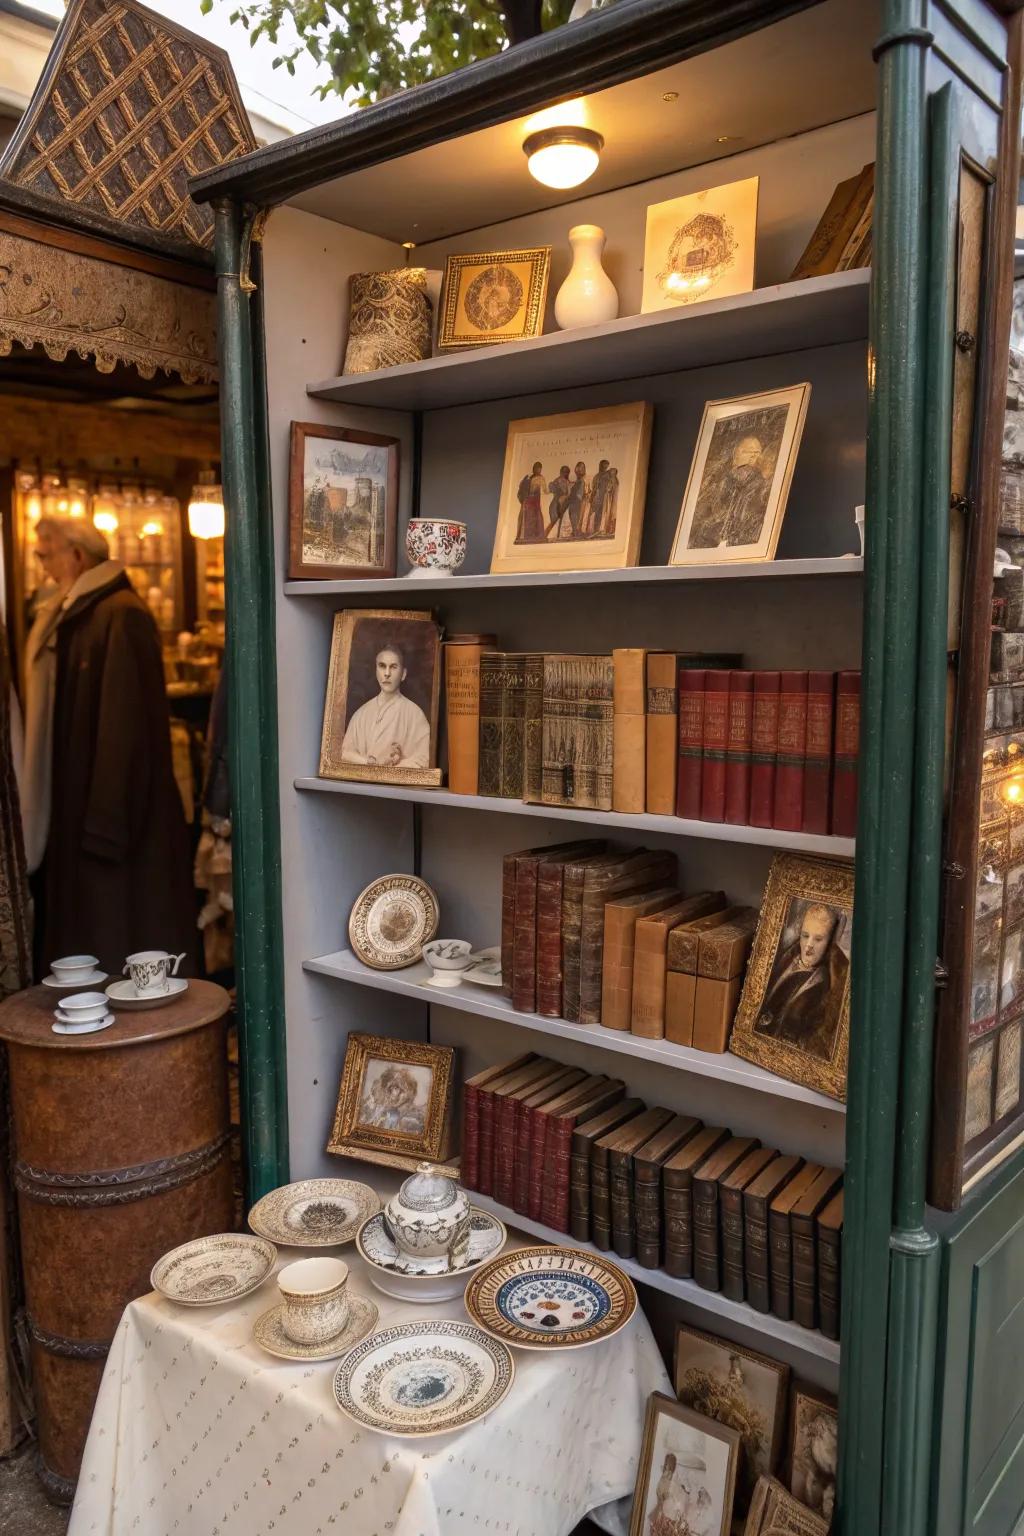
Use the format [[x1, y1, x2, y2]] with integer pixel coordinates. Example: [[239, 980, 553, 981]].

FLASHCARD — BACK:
[[0, 0, 256, 246]]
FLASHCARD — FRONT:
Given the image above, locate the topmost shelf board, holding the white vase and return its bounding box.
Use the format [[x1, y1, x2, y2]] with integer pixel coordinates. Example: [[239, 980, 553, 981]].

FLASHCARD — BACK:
[[307, 267, 870, 410]]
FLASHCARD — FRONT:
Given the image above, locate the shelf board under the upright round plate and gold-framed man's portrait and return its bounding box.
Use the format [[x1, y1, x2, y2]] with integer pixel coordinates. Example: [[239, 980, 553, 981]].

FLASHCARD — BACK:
[[302, 949, 846, 1115]]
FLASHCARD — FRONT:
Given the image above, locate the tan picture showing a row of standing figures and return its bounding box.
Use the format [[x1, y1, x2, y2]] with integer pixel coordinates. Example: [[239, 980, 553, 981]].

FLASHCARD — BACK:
[[491, 401, 652, 571]]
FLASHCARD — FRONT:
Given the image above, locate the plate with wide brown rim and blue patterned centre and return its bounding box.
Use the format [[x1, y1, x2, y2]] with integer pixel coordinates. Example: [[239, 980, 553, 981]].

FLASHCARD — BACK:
[[465, 1246, 637, 1349]]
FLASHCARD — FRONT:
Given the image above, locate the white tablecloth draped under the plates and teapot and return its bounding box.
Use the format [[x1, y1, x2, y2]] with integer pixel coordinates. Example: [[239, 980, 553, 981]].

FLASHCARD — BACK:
[[69, 1240, 671, 1536]]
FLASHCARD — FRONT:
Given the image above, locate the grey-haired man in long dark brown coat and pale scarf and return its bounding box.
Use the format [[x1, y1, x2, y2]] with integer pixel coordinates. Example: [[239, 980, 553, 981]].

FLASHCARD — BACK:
[[28, 519, 198, 975]]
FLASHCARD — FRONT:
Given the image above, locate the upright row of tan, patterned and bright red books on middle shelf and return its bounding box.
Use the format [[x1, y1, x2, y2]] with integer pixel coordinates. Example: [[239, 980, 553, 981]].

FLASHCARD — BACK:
[[445, 642, 860, 837]]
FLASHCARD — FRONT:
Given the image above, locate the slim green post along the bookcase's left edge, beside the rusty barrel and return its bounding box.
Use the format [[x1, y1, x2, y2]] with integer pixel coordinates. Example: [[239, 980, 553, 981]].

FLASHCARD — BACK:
[[215, 200, 289, 1203]]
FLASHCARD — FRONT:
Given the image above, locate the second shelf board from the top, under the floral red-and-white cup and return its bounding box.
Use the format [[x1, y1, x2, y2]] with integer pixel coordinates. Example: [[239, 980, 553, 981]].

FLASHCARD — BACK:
[[284, 554, 864, 598]]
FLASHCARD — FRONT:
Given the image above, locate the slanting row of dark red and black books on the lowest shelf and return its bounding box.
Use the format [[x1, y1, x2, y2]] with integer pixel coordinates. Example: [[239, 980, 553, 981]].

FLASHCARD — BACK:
[[461, 1054, 843, 1339]]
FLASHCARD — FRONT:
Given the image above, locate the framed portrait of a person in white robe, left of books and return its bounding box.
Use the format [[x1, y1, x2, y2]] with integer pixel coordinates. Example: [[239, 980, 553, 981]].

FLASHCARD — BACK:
[[319, 608, 441, 788]]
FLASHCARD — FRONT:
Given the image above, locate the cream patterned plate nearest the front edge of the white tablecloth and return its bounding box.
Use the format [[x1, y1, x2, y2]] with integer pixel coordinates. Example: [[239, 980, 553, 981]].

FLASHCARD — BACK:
[[335, 1319, 516, 1438]]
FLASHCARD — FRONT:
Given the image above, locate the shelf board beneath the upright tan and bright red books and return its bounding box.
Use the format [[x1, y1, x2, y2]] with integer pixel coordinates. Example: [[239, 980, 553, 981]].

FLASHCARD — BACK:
[[295, 774, 855, 859]]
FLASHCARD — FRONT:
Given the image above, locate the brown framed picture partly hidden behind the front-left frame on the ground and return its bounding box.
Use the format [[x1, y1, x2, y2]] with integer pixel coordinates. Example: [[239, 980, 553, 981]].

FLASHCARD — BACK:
[[676, 1322, 789, 1514]]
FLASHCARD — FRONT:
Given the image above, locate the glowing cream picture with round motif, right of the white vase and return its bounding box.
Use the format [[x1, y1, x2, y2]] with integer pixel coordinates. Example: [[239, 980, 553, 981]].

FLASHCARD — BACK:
[[640, 177, 757, 315]]
